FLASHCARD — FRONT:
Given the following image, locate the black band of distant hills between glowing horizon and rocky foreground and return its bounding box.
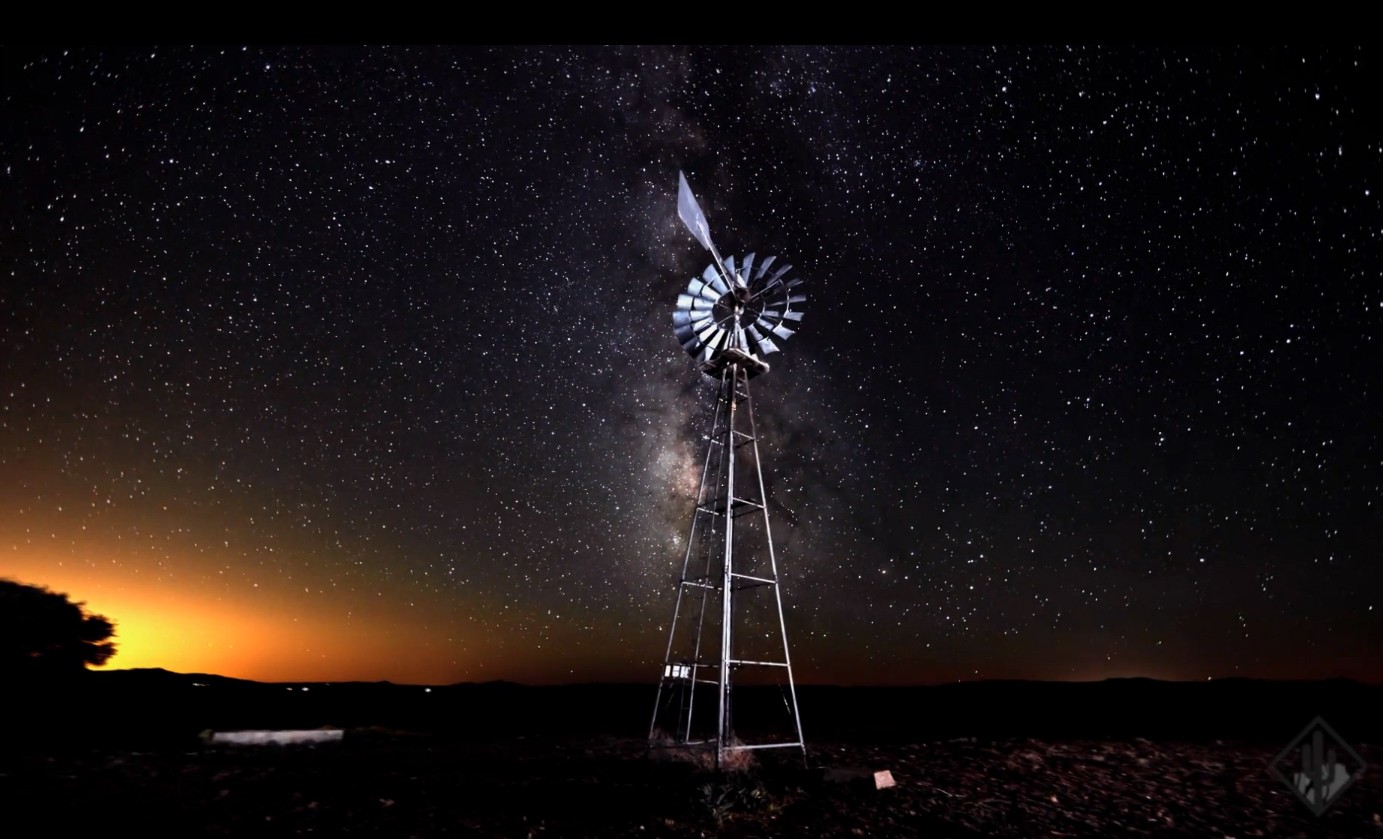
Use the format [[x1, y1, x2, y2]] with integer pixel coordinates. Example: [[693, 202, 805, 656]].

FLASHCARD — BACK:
[[8, 669, 1383, 745]]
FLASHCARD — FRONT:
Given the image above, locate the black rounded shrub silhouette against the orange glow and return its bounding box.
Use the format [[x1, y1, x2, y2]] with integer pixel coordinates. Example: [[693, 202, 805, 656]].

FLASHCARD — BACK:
[[0, 579, 115, 677]]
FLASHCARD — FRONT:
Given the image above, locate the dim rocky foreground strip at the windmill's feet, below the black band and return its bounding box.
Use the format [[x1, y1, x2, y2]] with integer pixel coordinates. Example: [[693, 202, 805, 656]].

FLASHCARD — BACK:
[[0, 728, 1383, 839]]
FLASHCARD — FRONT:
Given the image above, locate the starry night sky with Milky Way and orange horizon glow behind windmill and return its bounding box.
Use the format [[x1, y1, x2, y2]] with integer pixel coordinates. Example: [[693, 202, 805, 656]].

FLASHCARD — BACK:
[[0, 46, 1383, 684]]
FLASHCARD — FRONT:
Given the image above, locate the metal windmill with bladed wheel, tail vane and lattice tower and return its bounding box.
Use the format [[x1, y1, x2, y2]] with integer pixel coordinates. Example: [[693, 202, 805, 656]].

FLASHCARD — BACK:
[[649, 173, 806, 769]]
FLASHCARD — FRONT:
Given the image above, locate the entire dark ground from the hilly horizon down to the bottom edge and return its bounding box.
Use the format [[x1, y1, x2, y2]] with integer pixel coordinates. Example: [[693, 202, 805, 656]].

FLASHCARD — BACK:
[[0, 672, 1383, 839]]
